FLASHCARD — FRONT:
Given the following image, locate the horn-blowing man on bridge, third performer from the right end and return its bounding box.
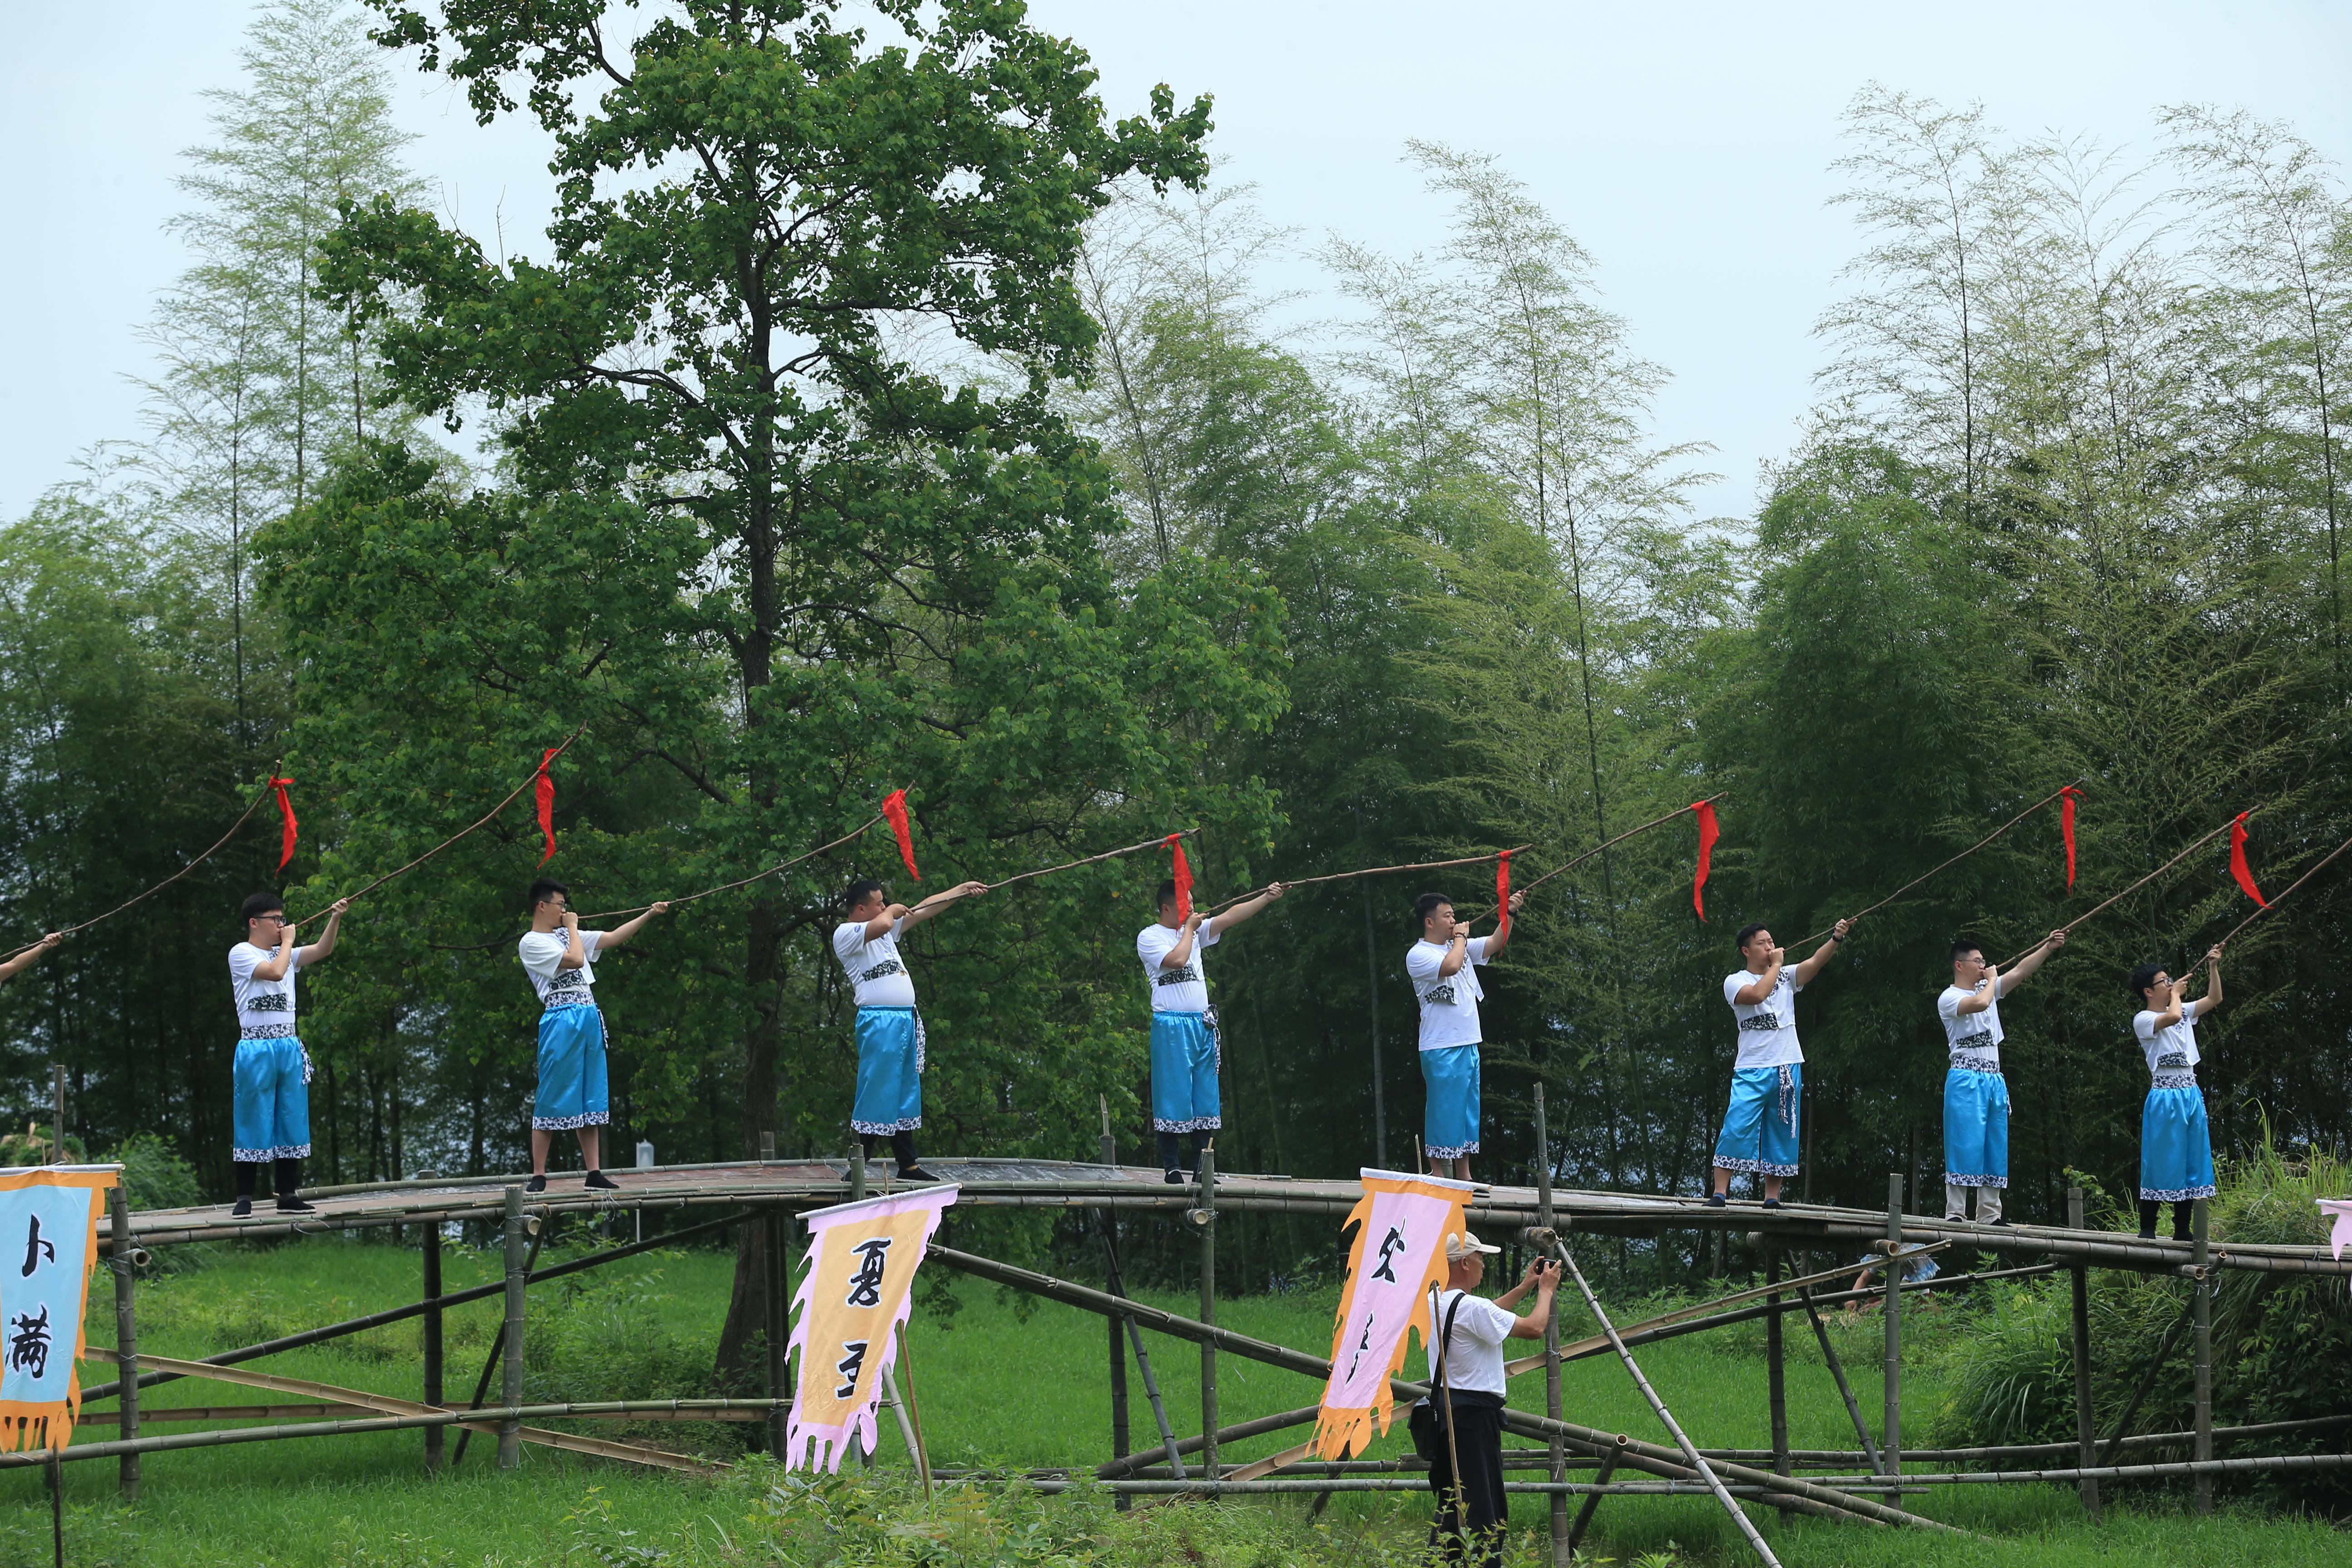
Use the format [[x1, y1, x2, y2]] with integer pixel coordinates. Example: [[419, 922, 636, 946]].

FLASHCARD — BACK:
[[1708, 919, 1853, 1208]]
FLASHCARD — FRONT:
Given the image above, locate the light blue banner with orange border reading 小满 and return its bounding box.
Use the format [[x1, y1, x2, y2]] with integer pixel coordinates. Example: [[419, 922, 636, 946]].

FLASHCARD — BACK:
[[0, 1166, 120, 1450]]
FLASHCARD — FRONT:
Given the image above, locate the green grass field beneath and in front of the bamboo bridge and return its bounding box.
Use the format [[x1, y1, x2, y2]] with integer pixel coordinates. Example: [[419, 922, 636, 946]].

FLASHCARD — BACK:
[[0, 1239, 2352, 1568]]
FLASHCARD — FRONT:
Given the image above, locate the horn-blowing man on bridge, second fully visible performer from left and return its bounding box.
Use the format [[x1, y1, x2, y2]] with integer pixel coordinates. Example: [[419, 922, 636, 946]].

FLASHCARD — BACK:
[[515, 877, 670, 1192]]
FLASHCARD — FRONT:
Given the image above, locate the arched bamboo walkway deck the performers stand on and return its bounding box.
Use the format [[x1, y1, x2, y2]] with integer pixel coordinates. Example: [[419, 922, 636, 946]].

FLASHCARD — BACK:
[[99, 1156, 2352, 1277]]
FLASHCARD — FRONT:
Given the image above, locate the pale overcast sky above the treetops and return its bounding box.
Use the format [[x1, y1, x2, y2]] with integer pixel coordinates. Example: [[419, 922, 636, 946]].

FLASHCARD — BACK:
[[0, 0, 2352, 517]]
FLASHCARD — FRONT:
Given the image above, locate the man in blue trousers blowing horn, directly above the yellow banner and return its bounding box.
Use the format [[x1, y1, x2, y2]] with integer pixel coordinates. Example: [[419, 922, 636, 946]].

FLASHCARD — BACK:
[[833, 882, 988, 1182]]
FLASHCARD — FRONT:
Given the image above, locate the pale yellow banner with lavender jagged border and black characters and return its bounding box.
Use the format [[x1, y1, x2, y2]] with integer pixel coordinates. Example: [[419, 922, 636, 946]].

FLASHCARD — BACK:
[[783, 1187, 957, 1469]]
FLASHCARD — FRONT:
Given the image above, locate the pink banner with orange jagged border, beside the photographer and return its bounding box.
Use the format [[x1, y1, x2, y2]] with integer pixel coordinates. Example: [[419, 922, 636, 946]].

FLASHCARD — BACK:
[[1315, 1171, 1477, 1460]]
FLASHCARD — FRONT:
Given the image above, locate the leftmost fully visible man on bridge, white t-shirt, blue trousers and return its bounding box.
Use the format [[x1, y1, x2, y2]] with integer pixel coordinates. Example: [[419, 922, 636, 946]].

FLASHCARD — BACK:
[[228, 893, 350, 1218]]
